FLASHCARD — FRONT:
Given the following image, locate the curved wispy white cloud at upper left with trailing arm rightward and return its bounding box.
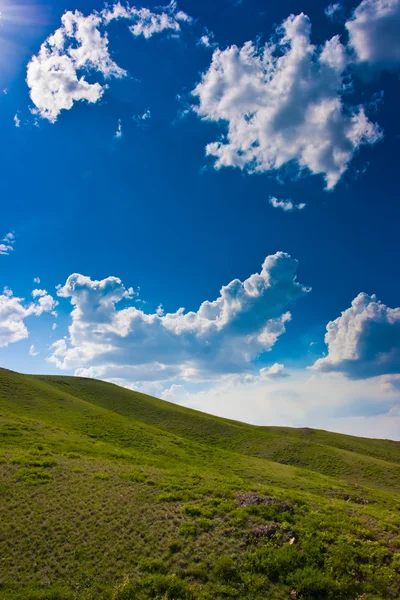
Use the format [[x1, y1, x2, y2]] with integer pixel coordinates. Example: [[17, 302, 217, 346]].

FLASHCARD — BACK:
[[27, 2, 190, 123]]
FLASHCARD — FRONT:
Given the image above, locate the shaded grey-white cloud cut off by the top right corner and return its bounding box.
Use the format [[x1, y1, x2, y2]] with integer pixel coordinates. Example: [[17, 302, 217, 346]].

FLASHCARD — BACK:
[[346, 0, 400, 69]]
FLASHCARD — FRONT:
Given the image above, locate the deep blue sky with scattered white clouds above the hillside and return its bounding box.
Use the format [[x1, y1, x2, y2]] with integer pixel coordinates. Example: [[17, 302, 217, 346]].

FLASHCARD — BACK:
[[0, 0, 400, 439]]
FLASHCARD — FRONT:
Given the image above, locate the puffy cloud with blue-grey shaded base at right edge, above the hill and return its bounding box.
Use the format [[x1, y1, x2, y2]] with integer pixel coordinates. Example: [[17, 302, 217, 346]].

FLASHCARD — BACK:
[[312, 294, 400, 379]]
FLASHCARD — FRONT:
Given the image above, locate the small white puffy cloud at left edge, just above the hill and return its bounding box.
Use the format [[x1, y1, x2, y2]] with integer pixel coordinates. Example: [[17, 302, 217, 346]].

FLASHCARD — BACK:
[[0, 288, 58, 347]]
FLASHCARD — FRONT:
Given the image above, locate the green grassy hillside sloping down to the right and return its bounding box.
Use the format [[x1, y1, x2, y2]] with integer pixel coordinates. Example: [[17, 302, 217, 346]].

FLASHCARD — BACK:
[[0, 370, 400, 600]]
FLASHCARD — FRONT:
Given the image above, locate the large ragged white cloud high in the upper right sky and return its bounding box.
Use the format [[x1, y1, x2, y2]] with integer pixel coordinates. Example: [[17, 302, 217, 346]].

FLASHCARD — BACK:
[[193, 13, 382, 189]]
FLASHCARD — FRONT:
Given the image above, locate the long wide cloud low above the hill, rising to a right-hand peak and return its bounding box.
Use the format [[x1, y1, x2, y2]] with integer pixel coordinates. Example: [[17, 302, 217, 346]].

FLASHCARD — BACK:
[[50, 252, 309, 382]]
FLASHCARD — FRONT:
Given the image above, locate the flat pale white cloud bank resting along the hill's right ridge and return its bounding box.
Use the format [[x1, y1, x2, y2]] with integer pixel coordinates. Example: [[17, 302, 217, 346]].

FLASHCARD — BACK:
[[162, 370, 400, 440]]
